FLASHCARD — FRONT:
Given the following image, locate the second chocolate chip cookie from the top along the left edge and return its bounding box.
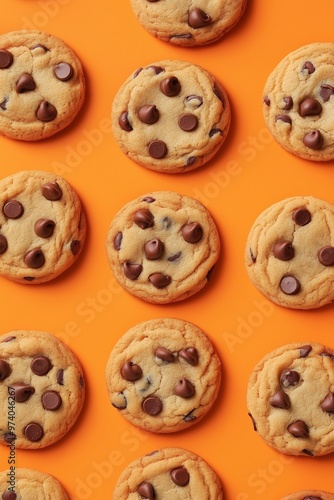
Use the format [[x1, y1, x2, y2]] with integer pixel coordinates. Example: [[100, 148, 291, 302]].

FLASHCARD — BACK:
[[0, 170, 86, 284]]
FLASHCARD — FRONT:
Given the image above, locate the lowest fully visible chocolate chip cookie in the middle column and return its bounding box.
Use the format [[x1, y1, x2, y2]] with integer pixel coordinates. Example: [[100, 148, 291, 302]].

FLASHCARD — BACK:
[[106, 318, 221, 433]]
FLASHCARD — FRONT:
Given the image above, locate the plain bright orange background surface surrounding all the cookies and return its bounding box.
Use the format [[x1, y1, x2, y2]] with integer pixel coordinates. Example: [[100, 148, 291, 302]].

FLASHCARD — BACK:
[[0, 0, 334, 500]]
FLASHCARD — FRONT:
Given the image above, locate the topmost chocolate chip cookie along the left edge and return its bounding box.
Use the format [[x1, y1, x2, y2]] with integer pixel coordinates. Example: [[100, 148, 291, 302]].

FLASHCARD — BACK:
[[0, 30, 85, 141]]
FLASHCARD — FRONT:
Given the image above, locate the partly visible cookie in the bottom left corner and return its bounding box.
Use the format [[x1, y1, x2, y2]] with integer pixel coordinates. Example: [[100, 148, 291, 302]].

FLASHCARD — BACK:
[[0, 468, 69, 500]]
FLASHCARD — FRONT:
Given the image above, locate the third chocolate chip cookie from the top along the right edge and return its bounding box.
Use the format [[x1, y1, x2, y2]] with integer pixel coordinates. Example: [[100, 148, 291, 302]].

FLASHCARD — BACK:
[[247, 343, 334, 456]]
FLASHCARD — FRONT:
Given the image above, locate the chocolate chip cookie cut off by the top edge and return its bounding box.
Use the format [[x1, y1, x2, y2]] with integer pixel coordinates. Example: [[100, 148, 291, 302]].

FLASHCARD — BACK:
[[131, 0, 246, 47]]
